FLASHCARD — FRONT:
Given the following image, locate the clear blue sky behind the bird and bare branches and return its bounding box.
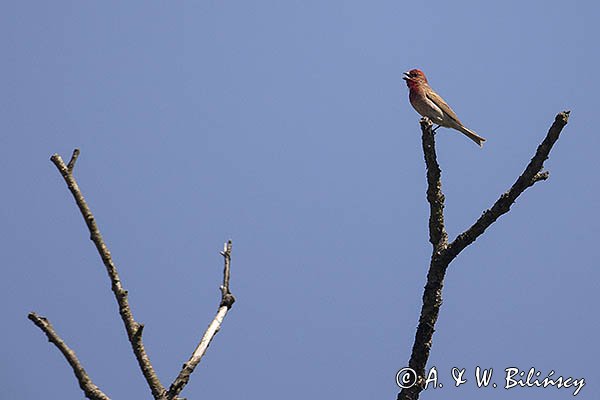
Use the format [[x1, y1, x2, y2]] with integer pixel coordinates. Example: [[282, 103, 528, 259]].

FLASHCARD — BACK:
[[0, 0, 600, 400]]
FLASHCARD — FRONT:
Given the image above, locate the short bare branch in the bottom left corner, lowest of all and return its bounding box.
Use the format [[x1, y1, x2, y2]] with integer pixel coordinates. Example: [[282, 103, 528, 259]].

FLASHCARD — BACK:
[[27, 312, 110, 400]]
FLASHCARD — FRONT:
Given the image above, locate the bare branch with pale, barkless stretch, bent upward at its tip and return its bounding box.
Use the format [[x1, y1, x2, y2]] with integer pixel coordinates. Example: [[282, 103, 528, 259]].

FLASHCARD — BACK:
[[167, 240, 235, 400]]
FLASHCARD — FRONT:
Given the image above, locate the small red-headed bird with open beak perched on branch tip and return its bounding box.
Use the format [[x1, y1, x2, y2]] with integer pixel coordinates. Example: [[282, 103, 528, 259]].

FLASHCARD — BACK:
[[402, 69, 485, 146]]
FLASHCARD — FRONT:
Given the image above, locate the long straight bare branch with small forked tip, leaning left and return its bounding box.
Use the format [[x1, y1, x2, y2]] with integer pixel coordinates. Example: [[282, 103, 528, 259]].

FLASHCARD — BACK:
[[50, 149, 165, 399]]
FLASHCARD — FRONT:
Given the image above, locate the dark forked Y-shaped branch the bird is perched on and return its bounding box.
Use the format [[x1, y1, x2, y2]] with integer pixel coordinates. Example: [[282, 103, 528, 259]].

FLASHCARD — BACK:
[[397, 111, 569, 400]]
